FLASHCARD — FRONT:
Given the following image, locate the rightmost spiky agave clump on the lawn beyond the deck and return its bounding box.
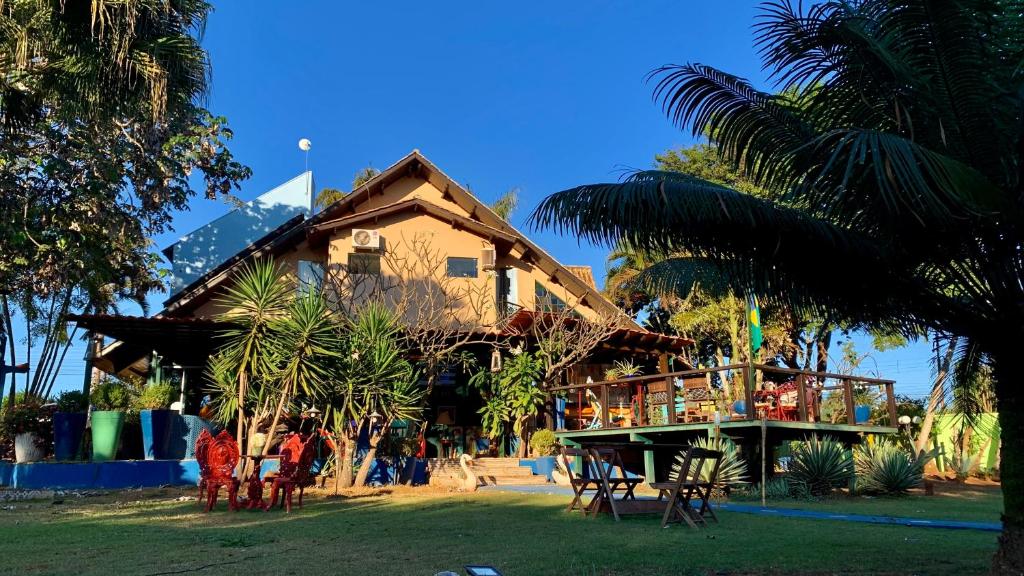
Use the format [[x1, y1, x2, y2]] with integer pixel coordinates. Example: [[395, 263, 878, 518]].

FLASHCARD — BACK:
[[854, 442, 932, 496]]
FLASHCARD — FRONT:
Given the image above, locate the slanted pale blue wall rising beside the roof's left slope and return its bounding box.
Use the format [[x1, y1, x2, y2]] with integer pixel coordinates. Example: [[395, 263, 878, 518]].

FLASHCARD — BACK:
[[164, 172, 313, 294]]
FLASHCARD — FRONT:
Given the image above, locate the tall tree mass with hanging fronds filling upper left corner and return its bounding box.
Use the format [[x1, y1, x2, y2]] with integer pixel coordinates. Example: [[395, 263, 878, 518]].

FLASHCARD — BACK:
[[0, 0, 249, 403]]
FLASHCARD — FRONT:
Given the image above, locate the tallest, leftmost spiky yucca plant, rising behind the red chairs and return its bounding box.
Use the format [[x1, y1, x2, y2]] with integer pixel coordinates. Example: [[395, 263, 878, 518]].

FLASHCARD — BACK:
[[210, 259, 292, 469]]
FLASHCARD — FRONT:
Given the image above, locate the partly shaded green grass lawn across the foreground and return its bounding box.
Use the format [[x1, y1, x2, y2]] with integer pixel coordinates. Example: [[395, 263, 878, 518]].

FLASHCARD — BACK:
[[0, 488, 997, 576]]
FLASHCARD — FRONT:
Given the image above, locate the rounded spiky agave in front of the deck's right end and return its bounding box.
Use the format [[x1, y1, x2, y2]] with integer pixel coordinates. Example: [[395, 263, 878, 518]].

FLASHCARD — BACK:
[[790, 437, 853, 496]]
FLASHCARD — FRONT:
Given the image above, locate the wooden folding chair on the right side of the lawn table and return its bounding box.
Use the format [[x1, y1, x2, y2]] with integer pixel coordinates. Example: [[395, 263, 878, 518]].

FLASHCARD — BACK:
[[650, 447, 722, 528]]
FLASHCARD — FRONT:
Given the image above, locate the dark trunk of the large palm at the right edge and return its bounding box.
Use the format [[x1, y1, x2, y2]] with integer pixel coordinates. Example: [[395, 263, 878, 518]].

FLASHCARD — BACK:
[[991, 338, 1024, 575]]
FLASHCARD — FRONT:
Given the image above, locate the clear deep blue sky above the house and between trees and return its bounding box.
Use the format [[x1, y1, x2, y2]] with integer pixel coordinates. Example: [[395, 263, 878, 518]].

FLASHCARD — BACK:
[[20, 1, 929, 395]]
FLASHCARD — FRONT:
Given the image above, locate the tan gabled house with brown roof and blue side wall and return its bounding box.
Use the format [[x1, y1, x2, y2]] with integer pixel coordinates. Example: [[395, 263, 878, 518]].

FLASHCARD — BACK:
[[76, 151, 691, 455]]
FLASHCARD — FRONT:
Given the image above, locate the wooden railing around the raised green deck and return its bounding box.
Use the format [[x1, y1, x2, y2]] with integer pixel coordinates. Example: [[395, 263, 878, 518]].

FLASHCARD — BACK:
[[552, 364, 896, 429]]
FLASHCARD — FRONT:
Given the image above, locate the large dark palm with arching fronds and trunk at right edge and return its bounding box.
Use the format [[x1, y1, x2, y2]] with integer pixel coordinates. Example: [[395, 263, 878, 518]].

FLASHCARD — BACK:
[[532, 0, 1024, 574]]
